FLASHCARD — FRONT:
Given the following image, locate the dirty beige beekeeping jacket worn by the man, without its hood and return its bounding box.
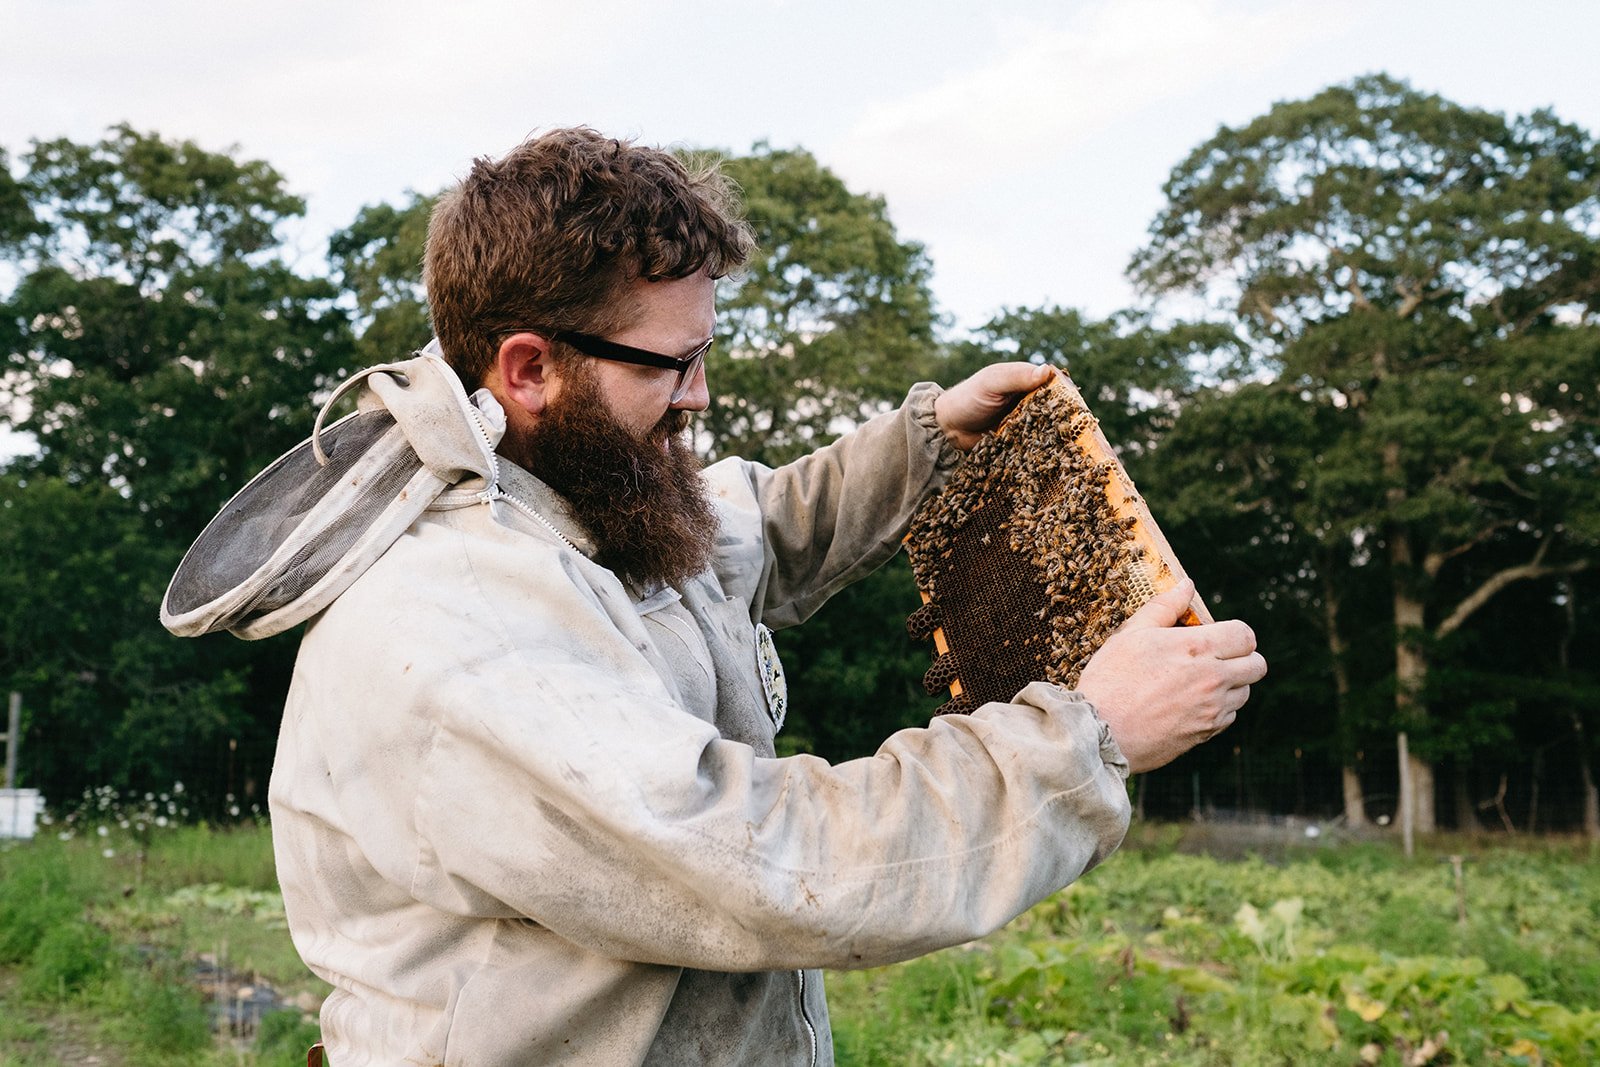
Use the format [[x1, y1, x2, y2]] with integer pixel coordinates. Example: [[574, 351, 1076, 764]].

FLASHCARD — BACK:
[[256, 355, 1128, 1067]]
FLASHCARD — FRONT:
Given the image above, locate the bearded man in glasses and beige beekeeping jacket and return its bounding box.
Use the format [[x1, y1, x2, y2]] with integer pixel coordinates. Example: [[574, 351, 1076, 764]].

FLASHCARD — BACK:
[[168, 130, 1266, 1067]]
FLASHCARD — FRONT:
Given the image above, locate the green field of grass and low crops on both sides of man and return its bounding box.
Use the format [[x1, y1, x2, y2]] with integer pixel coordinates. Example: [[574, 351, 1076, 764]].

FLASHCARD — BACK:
[[0, 806, 1600, 1067]]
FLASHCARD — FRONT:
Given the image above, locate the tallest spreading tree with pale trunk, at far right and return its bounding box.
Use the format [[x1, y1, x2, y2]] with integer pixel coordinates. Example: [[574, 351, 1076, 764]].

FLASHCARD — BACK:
[[1134, 75, 1600, 830]]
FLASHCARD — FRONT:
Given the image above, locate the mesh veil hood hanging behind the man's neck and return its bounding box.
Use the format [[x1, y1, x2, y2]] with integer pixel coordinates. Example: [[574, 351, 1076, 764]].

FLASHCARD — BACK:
[[162, 341, 506, 638]]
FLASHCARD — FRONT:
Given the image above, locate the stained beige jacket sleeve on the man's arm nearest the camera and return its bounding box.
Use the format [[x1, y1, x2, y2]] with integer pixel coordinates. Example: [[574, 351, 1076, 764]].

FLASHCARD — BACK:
[[388, 534, 1130, 971]]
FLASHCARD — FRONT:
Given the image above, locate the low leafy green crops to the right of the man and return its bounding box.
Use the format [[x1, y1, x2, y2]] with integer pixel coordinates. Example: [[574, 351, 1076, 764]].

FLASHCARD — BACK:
[[829, 848, 1600, 1065]]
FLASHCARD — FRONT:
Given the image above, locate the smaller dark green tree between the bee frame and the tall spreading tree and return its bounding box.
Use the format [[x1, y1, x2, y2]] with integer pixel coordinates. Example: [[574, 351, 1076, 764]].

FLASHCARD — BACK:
[[1141, 381, 1392, 827]]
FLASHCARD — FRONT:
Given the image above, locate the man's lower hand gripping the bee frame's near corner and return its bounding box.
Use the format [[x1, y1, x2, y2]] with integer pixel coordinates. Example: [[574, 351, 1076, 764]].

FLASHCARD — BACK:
[[1078, 579, 1267, 774]]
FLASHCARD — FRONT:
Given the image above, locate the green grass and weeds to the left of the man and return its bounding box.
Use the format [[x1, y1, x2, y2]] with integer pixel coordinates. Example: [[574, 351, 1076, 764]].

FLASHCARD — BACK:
[[0, 825, 326, 1065]]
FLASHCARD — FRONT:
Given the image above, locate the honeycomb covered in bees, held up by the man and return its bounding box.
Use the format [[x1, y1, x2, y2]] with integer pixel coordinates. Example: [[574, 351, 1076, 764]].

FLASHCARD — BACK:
[[906, 378, 1198, 713]]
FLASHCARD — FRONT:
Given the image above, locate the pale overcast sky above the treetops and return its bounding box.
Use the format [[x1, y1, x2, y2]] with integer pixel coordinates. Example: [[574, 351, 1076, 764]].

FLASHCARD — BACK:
[[0, 0, 1600, 334]]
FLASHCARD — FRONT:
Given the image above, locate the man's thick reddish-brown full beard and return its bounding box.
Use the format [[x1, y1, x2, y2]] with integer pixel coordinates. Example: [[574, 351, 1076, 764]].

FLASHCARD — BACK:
[[512, 365, 717, 585]]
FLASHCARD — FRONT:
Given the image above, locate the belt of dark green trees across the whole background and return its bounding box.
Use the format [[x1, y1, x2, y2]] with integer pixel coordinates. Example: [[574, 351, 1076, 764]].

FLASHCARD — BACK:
[[0, 87, 1600, 831]]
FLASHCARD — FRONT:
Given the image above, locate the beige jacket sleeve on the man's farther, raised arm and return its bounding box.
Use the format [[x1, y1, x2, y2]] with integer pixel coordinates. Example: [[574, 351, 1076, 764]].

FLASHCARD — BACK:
[[706, 382, 960, 629]]
